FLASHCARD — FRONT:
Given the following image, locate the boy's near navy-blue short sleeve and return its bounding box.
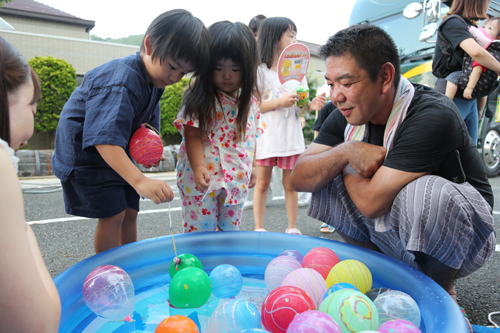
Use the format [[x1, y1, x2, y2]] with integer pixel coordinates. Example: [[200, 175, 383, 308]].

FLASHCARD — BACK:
[[82, 86, 139, 152]]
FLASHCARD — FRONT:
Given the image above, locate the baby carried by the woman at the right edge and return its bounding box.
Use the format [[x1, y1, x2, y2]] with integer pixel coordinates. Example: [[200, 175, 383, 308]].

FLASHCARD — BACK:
[[446, 17, 500, 114]]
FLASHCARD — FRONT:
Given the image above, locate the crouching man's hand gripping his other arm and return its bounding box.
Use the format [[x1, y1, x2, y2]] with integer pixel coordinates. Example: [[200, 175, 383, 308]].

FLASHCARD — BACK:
[[348, 141, 387, 178]]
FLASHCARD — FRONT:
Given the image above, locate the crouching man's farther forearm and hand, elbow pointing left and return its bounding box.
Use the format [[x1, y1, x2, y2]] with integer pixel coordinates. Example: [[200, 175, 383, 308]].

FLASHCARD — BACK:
[[290, 141, 385, 192]]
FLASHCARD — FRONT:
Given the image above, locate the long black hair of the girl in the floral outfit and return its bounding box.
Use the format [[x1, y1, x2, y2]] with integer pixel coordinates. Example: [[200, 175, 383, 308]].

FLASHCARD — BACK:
[[183, 21, 259, 141]]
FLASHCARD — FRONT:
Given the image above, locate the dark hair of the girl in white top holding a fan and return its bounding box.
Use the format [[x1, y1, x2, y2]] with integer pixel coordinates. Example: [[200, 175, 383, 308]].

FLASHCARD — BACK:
[[259, 17, 297, 68]]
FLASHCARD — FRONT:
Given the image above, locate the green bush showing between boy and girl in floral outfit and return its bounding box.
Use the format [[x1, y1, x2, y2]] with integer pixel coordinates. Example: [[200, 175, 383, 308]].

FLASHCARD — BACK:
[[160, 78, 189, 138]]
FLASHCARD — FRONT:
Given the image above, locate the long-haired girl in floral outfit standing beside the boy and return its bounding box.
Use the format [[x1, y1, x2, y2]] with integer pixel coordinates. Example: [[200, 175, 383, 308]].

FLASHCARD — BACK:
[[174, 21, 265, 233]]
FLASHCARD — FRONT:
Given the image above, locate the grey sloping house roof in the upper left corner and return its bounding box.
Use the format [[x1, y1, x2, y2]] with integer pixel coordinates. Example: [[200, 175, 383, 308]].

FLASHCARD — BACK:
[[0, 0, 95, 31]]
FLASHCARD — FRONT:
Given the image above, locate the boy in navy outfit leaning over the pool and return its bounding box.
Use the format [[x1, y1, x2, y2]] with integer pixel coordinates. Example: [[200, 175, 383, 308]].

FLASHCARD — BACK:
[[52, 9, 209, 253]]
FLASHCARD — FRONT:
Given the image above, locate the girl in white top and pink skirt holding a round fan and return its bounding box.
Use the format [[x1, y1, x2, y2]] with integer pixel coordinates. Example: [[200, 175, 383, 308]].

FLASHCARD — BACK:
[[253, 17, 326, 235]]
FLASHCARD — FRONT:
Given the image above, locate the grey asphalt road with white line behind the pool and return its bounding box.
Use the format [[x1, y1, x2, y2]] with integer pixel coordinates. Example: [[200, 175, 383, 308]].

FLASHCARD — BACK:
[[21, 173, 500, 326]]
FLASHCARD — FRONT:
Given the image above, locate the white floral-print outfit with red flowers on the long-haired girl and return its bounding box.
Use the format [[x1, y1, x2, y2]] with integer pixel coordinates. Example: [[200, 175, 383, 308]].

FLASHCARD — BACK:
[[174, 91, 266, 231]]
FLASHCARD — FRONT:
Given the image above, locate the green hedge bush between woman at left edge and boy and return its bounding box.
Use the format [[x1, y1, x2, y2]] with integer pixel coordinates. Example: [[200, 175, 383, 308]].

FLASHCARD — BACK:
[[28, 56, 76, 132]]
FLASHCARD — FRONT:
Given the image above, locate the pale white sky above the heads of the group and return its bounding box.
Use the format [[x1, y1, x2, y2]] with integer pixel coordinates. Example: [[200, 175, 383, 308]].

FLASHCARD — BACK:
[[37, 0, 356, 45]]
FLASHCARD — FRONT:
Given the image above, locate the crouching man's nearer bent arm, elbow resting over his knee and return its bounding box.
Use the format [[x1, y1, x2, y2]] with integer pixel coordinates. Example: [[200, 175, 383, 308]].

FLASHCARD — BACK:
[[343, 166, 426, 218]]
